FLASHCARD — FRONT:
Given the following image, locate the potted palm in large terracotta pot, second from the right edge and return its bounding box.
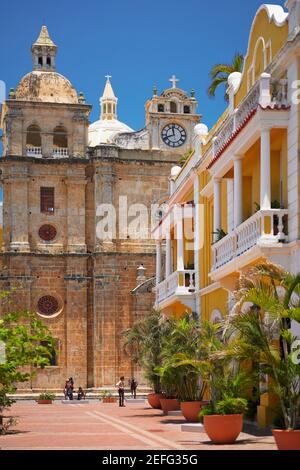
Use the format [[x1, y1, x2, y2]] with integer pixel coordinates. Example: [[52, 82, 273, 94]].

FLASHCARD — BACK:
[[195, 322, 253, 444]]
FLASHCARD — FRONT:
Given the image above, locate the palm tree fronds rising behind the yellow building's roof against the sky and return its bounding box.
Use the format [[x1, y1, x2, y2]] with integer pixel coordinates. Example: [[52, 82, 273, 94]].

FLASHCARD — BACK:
[[208, 52, 244, 101]]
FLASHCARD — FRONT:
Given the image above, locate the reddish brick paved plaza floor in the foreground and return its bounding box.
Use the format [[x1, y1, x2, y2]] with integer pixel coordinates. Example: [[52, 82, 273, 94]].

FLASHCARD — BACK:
[[0, 402, 276, 450]]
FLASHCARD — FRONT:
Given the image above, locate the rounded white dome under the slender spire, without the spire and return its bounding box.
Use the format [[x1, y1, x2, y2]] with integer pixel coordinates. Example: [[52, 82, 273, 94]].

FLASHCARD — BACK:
[[89, 119, 134, 147]]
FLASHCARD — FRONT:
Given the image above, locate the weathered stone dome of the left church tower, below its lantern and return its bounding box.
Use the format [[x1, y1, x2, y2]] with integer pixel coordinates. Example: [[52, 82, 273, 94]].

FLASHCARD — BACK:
[[16, 70, 78, 104]]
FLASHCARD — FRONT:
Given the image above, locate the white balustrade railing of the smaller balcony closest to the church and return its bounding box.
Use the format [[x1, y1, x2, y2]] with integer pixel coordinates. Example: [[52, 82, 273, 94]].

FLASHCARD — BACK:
[[156, 270, 195, 303]]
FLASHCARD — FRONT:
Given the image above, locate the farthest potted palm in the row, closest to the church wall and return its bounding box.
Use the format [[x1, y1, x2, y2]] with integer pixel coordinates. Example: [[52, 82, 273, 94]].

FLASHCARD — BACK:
[[123, 310, 171, 409]]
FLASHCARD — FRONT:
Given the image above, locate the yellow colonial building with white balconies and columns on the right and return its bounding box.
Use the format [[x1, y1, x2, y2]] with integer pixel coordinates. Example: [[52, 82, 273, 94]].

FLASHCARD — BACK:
[[153, 0, 300, 424]]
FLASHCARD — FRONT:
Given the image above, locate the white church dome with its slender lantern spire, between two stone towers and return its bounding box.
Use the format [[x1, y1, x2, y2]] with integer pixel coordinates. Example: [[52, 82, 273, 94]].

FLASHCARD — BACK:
[[89, 75, 134, 147]]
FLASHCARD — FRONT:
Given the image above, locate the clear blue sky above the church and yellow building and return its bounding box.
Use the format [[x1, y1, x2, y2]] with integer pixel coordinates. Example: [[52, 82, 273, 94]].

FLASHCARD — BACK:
[[0, 0, 284, 130]]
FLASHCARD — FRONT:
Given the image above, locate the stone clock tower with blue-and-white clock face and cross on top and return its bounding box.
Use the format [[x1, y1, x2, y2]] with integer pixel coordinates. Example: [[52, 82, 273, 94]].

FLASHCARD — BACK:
[[146, 75, 200, 155]]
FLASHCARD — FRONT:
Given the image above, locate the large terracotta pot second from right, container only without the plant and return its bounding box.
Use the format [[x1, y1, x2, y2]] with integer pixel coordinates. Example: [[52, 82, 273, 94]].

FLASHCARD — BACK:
[[203, 415, 243, 444]]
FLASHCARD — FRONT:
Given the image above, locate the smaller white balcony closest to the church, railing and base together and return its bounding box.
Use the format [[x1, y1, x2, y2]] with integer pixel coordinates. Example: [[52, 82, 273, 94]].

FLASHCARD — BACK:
[[156, 270, 195, 310]]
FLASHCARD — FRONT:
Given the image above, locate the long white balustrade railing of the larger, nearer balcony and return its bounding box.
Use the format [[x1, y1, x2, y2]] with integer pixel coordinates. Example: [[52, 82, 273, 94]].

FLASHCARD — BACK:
[[212, 209, 288, 271]]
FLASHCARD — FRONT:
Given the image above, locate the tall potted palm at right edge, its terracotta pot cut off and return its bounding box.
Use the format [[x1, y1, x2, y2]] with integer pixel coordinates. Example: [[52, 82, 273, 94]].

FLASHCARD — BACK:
[[228, 264, 300, 450]]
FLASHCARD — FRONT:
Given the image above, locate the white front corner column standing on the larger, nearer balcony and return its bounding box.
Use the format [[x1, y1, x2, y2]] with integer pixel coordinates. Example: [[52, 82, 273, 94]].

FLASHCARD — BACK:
[[260, 128, 271, 209]]
